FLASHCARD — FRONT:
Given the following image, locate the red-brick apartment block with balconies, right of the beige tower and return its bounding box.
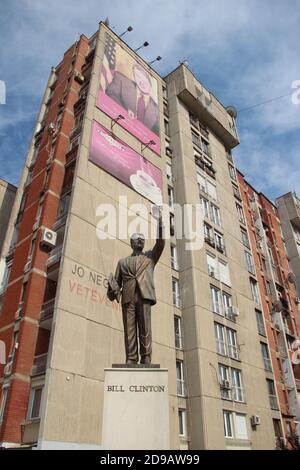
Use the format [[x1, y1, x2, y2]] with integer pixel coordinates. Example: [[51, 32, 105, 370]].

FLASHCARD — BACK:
[[238, 172, 300, 439]]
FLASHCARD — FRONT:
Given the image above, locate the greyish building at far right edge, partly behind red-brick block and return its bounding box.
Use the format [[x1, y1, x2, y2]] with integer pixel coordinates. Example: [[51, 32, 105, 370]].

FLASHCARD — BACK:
[[276, 192, 300, 302]]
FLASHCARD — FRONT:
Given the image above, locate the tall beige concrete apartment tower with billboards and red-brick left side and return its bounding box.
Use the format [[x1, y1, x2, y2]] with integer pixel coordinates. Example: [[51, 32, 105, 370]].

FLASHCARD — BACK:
[[0, 23, 297, 449]]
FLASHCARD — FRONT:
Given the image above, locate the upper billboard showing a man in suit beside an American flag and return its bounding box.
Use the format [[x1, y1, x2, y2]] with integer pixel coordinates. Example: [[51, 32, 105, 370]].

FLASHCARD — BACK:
[[97, 33, 160, 154]]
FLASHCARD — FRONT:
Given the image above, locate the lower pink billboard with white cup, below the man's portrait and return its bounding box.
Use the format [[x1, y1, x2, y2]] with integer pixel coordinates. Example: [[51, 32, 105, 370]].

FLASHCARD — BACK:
[[89, 121, 162, 205]]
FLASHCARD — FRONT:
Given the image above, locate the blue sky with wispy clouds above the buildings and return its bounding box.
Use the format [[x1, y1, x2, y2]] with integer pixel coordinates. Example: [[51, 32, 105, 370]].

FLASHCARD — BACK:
[[0, 0, 300, 199]]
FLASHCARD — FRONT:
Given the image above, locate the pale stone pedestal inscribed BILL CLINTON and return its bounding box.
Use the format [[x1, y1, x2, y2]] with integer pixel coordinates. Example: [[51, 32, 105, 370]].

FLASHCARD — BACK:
[[102, 366, 170, 450]]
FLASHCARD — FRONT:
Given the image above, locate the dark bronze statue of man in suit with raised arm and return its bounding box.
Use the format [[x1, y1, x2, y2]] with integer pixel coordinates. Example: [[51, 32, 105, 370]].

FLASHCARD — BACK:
[[107, 211, 165, 364]]
